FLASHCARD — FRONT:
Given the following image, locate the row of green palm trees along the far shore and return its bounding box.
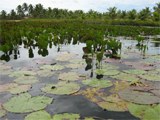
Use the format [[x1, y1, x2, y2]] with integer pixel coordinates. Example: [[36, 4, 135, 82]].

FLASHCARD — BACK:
[[0, 2, 160, 21]]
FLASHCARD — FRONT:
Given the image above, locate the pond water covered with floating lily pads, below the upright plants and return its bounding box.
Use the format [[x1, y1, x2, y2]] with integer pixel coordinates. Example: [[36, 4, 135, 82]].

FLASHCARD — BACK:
[[0, 37, 160, 120]]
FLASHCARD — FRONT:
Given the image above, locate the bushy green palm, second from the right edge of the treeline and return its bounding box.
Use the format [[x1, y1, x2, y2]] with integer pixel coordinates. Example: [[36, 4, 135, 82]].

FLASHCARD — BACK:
[[138, 7, 151, 20]]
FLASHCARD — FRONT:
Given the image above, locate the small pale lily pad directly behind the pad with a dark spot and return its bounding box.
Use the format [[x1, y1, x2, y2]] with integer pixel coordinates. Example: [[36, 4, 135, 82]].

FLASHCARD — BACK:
[[58, 72, 79, 81]]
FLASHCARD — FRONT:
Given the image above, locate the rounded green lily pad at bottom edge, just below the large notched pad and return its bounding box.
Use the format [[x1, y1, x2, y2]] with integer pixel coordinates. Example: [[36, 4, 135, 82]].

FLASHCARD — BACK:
[[25, 110, 53, 120]]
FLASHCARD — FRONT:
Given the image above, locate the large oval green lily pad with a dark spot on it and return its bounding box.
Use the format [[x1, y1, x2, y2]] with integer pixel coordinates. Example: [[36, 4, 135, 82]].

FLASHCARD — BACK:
[[41, 82, 80, 95]]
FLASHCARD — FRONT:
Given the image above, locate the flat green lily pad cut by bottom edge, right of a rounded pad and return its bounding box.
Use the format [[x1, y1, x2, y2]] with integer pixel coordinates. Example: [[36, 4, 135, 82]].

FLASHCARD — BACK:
[[53, 113, 80, 120]]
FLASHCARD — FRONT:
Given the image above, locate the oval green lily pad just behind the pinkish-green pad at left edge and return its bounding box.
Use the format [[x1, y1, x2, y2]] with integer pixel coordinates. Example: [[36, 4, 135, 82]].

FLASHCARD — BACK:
[[14, 76, 38, 84]]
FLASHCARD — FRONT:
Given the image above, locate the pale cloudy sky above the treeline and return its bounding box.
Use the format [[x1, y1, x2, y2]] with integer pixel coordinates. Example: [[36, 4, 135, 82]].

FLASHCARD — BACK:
[[0, 0, 160, 12]]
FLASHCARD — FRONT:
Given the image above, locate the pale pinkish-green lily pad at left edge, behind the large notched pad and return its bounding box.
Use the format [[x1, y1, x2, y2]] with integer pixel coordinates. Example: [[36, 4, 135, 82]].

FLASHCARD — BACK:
[[0, 83, 31, 94]]
